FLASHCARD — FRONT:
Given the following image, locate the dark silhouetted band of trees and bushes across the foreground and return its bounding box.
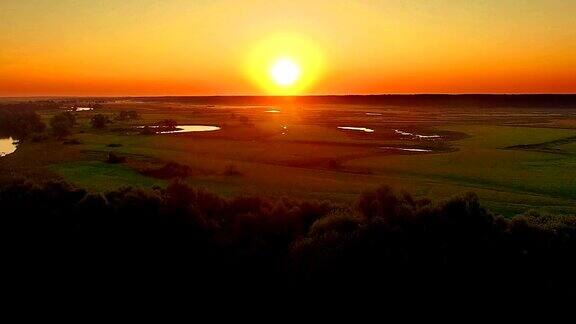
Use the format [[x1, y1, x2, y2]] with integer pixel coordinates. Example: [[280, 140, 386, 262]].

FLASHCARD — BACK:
[[0, 181, 576, 298]]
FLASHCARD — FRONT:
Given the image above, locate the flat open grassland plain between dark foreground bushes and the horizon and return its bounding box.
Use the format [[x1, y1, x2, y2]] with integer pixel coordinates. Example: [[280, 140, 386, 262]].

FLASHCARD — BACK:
[[0, 101, 576, 216]]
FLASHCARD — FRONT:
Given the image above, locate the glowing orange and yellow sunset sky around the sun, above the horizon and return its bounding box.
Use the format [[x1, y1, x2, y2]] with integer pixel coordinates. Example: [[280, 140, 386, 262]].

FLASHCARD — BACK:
[[0, 0, 576, 96]]
